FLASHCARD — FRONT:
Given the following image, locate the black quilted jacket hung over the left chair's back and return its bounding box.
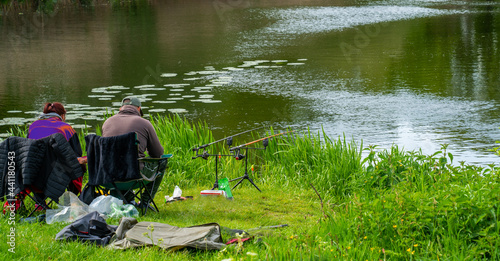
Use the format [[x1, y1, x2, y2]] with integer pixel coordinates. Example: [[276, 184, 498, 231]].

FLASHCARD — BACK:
[[0, 133, 83, 202]]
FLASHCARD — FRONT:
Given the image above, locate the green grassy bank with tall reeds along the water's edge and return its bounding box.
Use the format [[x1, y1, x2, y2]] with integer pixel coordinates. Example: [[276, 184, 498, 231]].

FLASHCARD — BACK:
[[0, 116, 500, 260]]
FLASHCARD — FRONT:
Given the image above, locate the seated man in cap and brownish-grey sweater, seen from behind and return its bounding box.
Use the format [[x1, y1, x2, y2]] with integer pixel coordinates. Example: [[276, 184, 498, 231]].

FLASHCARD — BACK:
[[102, 96, 163, 207]]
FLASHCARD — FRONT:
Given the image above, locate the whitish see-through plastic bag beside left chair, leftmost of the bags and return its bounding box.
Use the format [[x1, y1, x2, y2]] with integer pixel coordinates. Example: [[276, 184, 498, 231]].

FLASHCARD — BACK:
[[46, 191, 89, 224]]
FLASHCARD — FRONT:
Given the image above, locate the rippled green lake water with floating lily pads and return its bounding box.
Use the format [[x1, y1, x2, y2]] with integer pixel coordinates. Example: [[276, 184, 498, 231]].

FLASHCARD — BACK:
[[0, 0, 500, 165]]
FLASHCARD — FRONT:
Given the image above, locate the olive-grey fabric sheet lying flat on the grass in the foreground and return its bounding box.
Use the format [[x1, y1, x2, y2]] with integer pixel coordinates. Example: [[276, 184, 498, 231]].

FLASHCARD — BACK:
[[108, 218, 226, 250]]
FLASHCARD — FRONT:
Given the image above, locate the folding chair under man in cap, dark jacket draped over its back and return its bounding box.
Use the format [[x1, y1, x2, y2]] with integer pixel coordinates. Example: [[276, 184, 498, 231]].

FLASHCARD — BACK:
[[85, 132, 172, 214]]
